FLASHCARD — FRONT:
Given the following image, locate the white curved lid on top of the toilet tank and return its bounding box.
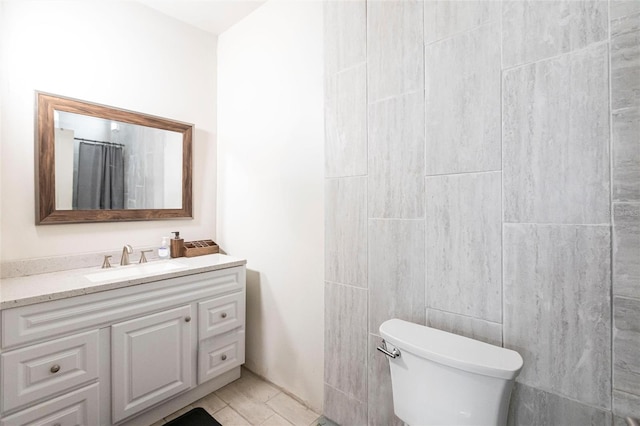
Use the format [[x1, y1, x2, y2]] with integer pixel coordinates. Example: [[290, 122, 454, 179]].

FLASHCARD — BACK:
[[380, 319, 523, 380]]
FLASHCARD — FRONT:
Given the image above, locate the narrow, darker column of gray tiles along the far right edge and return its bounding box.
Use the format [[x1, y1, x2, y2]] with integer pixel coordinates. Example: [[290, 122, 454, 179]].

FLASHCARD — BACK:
[[610, 0, 640, 418]]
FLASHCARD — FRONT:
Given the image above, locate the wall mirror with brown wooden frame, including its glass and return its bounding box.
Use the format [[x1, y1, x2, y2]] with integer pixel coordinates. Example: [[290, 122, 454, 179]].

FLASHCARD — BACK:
[[36, 92, 193, 225]]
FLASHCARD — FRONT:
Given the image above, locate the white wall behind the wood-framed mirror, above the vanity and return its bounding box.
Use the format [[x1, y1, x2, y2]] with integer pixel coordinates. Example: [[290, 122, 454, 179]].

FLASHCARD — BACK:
[[0, 0, 216, 261]]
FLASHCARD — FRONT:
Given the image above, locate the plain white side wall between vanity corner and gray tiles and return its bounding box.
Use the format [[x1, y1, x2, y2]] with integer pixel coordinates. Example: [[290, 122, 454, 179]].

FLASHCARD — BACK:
[[218, 0, 324, 410]]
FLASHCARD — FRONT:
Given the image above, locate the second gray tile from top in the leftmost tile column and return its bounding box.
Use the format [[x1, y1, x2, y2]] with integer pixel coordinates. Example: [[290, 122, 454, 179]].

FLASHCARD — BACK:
[[324, 63, 367, 177]]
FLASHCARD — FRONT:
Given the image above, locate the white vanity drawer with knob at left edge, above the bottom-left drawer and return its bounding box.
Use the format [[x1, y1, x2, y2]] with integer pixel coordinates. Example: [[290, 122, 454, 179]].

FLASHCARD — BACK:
[[1, 330, 98, 412]]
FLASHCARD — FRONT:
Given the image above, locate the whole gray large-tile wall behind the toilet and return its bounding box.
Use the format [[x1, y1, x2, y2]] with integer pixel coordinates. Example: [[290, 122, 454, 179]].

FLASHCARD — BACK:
[[324, 0, 640, 426]]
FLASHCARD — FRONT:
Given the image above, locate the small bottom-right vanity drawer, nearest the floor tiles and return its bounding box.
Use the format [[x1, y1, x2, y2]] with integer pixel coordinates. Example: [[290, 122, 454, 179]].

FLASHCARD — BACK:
[[198, 330, 244, 384]]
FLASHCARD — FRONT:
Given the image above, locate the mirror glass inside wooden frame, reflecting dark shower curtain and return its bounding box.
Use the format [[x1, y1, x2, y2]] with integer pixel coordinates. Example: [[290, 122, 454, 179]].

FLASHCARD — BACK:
[[54, 110, 182, 210]]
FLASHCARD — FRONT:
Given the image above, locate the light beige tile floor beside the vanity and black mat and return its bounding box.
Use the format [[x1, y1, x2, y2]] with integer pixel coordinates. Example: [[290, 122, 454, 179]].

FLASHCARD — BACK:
[[152, 368, 321, 426]]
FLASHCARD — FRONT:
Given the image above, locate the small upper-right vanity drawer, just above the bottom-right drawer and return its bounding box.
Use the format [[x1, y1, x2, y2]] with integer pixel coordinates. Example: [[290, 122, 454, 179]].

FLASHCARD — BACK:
[[198, 292, 245, 340]]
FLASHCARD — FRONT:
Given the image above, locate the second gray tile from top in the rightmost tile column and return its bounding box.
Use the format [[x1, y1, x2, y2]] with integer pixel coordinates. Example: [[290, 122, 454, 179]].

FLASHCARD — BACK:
[[611, 30, 640, 111]]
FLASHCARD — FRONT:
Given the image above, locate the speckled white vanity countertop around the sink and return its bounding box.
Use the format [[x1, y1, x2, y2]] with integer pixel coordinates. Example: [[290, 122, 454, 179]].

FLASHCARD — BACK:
[[0, 254, 247, 310]]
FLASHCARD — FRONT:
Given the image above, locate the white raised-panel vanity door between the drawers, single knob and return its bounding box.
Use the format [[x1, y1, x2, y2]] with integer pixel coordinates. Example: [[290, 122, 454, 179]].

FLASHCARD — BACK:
[[111, 306, 193, 423]]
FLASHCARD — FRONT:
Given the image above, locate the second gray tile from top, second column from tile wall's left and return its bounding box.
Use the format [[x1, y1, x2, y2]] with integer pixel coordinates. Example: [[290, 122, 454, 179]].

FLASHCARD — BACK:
[[369, 92, 424, 219]]
